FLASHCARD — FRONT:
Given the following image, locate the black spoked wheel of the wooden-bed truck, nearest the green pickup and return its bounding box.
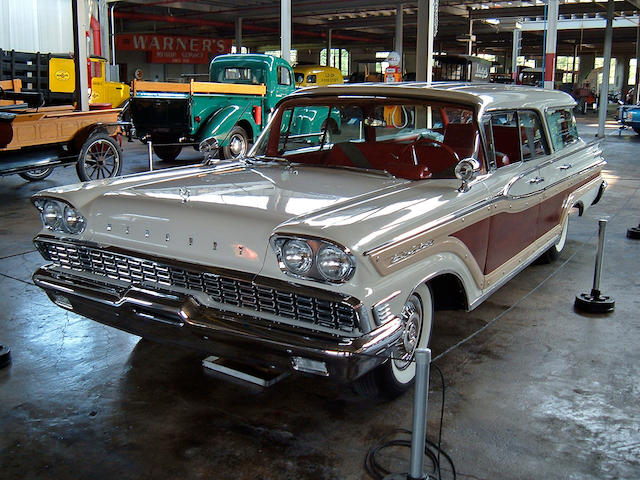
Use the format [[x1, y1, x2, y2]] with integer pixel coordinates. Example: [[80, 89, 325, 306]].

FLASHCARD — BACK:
[[76, 133, 122, 182]]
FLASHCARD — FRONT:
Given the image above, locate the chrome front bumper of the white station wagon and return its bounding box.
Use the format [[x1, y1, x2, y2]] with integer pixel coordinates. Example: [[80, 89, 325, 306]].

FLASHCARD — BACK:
[[33, 266, 402, 382]]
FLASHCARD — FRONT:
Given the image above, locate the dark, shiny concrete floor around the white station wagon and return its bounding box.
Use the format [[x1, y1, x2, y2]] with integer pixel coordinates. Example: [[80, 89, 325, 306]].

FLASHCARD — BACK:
[[0, 116, 640, 480]]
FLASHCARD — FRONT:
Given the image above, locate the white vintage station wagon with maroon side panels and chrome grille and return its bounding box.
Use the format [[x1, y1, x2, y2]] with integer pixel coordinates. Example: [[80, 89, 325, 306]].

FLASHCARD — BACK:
[[33, 83, 606, 396]]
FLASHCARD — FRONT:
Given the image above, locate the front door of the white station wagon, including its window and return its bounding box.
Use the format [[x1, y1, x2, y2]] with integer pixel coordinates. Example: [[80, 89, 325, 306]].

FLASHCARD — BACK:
[[484, 110, 549, 275]]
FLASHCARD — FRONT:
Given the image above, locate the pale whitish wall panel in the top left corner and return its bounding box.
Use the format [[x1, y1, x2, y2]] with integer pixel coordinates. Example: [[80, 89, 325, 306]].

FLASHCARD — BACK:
[[0, 0, 73, 53]]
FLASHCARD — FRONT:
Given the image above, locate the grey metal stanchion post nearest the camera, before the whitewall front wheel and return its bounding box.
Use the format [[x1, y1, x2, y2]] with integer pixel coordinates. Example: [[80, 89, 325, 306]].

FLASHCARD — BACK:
[[408, 348, 431, 480]]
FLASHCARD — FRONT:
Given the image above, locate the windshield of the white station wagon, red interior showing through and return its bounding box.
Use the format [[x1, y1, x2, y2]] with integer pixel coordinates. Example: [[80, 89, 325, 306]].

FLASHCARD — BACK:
[[252, 97, 484, 180]]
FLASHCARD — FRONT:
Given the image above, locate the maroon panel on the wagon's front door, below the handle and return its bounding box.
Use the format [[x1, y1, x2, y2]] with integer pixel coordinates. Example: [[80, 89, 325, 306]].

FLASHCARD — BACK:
[[484, 205, 539, 275]]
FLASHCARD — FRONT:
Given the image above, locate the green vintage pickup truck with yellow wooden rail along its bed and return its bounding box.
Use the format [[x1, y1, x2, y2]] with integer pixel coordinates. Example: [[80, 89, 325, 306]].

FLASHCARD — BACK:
[[130, 54, 300, 161]]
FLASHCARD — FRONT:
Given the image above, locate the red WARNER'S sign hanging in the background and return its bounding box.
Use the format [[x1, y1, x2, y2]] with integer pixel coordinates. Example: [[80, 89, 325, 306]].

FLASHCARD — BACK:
[[116, 33, 231, 63]]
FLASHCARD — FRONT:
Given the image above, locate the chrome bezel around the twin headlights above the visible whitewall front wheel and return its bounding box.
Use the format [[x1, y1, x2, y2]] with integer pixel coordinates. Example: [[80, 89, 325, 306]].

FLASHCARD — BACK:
[[270, 234, 356, 284]]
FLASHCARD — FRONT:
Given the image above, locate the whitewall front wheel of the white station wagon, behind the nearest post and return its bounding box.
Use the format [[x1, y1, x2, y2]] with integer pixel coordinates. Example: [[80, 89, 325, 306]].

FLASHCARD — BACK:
[[354, 285, 433, 399]]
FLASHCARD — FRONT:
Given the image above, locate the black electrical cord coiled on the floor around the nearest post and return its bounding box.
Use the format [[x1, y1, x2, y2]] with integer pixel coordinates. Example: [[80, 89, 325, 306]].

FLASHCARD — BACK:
[[364, 362, 456, 480]]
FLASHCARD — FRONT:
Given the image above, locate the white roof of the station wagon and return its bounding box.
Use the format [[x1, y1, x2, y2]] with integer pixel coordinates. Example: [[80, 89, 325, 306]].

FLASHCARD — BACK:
[[284, 82, 575, 111]]
